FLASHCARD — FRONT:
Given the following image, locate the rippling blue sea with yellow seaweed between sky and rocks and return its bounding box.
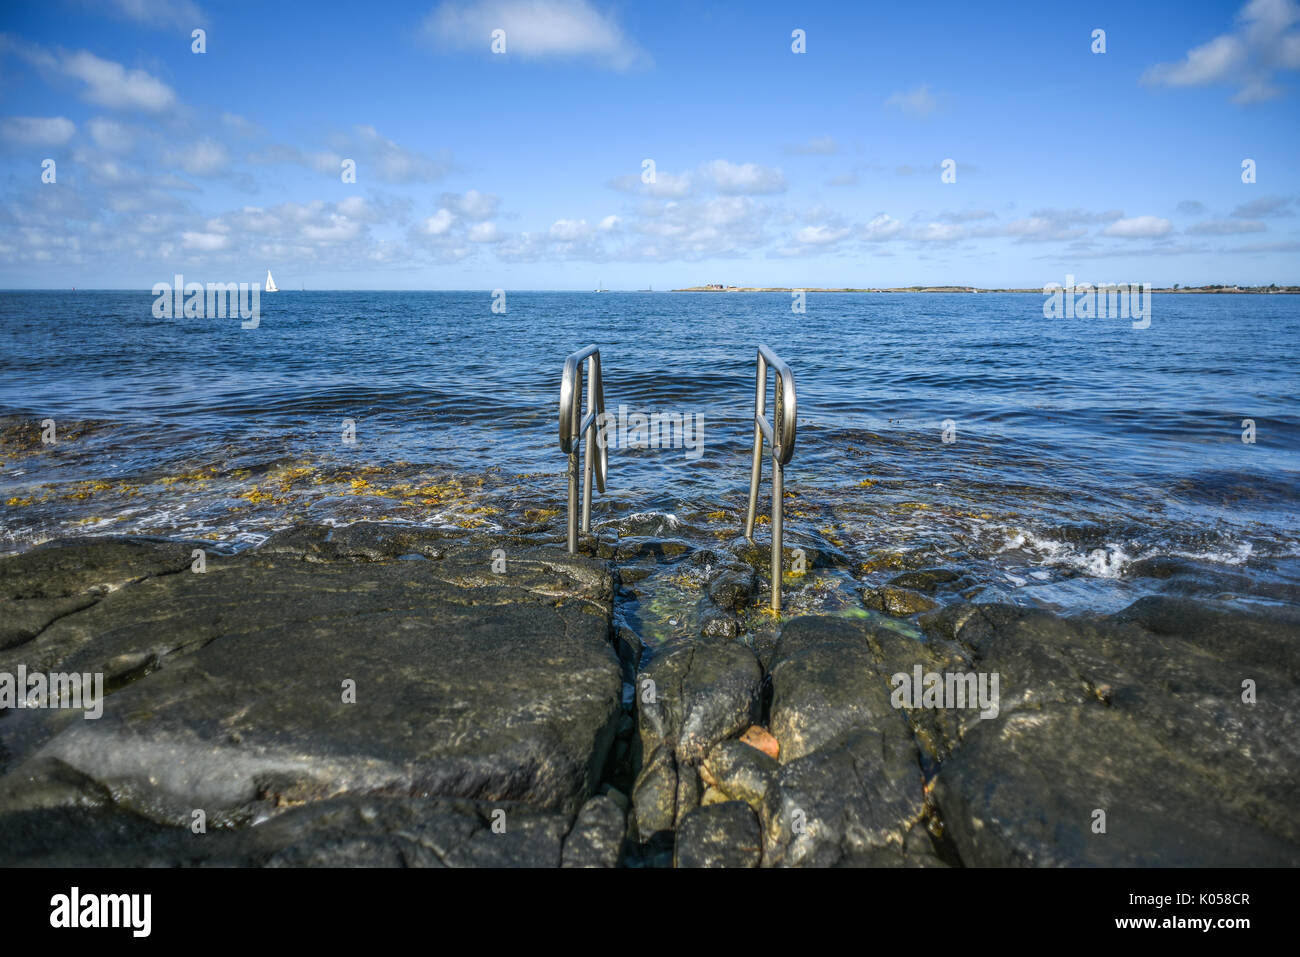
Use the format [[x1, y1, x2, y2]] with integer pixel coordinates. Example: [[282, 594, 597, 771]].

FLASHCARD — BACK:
[[0, 291, 1300, 624]]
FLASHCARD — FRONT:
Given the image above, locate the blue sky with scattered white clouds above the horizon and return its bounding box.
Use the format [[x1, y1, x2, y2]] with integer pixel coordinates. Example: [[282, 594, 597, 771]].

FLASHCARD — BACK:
[[0, 0, 1300, 289]]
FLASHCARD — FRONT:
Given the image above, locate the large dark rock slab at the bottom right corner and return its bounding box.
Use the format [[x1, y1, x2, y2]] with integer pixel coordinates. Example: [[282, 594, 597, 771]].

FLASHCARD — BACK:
[[933, 598, 1300, 866]]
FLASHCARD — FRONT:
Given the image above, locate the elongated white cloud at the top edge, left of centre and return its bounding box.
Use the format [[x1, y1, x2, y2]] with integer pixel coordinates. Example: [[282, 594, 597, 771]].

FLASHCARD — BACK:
[[425, 0, 649, 70]]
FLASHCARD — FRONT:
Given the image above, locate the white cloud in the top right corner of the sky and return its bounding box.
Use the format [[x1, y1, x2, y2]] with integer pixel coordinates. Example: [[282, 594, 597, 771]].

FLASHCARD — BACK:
[[1141, 0, 1300, 104]]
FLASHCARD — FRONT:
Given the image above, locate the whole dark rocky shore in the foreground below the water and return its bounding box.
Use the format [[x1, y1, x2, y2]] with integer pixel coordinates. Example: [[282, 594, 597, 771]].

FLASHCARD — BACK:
[[0, 523, 1300, 867]]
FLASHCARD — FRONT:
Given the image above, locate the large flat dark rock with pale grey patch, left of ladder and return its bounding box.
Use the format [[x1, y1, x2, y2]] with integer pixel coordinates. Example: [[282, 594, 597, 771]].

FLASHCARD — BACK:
[[0, 527, 621, 859]]
